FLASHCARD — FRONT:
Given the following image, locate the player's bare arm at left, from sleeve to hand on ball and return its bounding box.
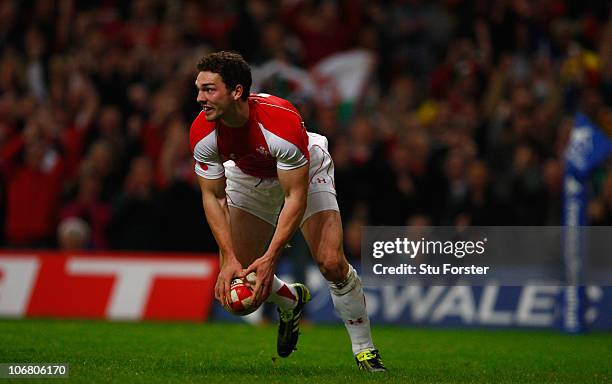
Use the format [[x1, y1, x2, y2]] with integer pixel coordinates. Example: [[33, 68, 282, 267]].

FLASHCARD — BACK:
[[198, 176, 243, 305]]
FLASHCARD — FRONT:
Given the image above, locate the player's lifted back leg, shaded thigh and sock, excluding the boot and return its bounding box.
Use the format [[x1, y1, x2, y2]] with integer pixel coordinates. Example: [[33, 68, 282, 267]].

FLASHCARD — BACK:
[[229, 205, 298, 310]]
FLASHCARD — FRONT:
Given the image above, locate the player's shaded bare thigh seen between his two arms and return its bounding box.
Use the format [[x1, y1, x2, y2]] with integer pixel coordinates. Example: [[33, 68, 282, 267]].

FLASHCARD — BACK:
[[229, 206, 274, 268]]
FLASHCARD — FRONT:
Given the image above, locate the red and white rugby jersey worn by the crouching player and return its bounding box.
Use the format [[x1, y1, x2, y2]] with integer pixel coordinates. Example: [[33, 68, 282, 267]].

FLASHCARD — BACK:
[[189, 94, 309, 179]]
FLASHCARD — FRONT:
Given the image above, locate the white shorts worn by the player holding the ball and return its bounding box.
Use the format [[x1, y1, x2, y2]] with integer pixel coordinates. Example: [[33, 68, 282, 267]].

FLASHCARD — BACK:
[[223, 132, 340, 226]]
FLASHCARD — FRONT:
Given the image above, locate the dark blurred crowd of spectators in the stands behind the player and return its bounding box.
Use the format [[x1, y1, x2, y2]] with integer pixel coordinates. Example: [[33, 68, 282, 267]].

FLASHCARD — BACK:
[[0, 0, 612, 254]]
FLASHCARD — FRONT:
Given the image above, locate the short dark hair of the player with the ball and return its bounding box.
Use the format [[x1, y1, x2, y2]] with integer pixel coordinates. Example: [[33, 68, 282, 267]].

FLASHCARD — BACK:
[[197, 51, 253, 100]]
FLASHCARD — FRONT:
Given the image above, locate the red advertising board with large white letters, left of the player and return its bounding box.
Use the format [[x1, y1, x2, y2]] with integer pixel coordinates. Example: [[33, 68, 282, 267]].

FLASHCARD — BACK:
[[0, 251, 219, 321]]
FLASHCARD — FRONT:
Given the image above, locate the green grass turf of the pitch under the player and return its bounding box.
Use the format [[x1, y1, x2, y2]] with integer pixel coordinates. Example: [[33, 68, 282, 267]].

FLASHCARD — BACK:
[[0, 320, 612, 384]]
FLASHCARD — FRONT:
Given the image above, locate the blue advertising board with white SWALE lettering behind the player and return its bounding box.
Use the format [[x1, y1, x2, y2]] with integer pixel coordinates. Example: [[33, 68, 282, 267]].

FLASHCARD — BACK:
[[213, 265, 612, 330]]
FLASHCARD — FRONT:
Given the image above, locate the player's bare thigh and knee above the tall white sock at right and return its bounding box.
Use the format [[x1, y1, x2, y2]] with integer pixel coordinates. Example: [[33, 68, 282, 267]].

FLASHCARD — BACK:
[[302, 210, 348, 282]]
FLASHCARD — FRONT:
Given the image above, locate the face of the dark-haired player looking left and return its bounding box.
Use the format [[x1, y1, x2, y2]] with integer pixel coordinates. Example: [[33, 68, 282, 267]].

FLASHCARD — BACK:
[[195, 72, 236, 121]]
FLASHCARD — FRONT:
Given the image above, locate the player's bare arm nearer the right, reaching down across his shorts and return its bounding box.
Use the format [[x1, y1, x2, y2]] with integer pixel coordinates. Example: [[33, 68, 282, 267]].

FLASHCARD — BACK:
[[247, 163, 308, 304]]
